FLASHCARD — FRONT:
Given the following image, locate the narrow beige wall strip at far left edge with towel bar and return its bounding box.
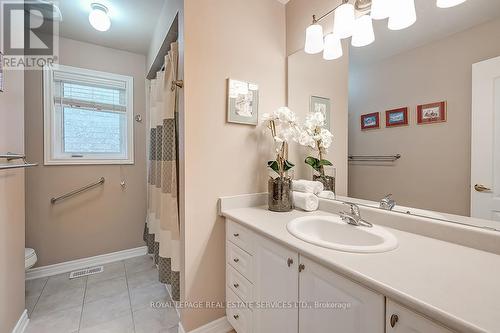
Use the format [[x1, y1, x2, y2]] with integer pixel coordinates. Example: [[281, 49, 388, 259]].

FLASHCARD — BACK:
[[0, 70, 25, 332]]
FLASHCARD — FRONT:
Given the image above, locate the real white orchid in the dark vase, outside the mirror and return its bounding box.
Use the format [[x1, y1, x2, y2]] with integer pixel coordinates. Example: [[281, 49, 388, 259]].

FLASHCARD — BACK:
[[262, 107, 301, 178]]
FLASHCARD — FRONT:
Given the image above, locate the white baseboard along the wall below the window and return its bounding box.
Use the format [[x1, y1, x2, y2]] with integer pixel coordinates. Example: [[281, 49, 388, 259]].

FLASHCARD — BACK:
[[26, 246, 148, 280]]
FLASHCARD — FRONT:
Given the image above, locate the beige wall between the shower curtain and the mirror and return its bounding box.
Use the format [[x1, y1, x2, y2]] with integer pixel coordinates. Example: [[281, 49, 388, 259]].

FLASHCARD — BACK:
[[182, 0, 286, 331]]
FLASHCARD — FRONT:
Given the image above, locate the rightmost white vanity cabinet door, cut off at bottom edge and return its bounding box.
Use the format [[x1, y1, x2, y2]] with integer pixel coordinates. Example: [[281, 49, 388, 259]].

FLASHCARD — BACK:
[[386, 299, 452, 333]]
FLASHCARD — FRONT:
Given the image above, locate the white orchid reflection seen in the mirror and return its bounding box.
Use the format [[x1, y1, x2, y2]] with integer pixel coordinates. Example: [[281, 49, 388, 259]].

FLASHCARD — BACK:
[[298, 111, 333, 177]]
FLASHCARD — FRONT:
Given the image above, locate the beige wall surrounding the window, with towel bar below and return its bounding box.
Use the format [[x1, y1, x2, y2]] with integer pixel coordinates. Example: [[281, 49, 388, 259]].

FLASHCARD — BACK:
[[25, 38, 147, 266]]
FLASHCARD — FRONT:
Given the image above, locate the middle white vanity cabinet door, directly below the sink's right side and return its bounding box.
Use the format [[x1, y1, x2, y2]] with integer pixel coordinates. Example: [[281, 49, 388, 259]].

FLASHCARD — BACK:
[[299, 256, 385, 333]]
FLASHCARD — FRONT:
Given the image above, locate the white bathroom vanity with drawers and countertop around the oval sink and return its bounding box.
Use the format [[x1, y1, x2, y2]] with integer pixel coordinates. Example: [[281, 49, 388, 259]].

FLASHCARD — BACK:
[[220, 195, 500, 333]]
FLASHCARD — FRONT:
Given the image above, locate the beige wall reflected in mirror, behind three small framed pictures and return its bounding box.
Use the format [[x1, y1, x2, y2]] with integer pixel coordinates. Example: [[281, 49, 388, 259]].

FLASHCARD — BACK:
[[349, 20, 500, 215]]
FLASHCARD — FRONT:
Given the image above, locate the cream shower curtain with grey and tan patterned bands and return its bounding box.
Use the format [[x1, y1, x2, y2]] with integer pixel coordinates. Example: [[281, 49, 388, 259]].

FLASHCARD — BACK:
[[144, 42, 181, 301]]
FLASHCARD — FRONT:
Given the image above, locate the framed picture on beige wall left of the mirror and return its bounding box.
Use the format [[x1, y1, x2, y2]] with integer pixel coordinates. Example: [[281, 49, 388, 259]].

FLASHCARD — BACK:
[[227, 79, 259, 125]]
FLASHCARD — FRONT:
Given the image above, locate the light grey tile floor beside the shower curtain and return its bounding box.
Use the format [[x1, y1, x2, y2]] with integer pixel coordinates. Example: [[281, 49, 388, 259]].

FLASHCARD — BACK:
[[26, 256, 179, 333]]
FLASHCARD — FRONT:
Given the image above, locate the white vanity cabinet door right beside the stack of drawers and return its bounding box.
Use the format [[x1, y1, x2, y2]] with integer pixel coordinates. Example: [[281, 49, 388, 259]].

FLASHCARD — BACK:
[[253, 232, 299, 333]]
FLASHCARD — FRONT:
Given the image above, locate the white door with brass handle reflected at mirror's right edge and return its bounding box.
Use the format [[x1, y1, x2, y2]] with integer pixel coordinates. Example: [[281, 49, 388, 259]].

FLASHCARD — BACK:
[[471, 57, 500, 222]]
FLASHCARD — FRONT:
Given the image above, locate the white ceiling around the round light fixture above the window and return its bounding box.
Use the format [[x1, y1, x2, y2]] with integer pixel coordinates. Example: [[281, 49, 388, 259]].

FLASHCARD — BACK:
[[58, 0, 165, 54]]
